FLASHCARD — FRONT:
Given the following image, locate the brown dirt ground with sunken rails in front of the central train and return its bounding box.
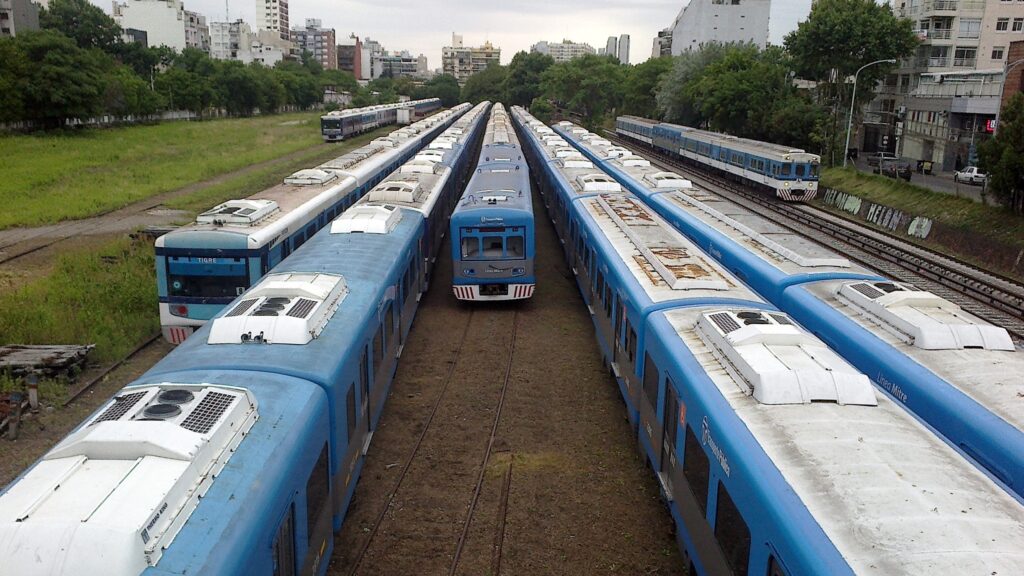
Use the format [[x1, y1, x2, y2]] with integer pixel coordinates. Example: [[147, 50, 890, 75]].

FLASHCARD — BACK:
[[329, 181, 684, 575]]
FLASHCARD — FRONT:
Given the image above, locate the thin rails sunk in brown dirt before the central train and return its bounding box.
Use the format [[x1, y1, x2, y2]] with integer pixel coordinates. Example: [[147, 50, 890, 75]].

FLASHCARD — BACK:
[[347, 308, 519, 576]]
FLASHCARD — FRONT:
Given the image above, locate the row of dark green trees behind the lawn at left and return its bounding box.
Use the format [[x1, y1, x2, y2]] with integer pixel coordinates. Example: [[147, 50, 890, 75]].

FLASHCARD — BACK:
[[0, 0, 370, 126]]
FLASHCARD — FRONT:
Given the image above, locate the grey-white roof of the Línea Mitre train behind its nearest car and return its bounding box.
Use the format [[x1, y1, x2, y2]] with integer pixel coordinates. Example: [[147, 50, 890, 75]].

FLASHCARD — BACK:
[[567, 126, 874, 277]]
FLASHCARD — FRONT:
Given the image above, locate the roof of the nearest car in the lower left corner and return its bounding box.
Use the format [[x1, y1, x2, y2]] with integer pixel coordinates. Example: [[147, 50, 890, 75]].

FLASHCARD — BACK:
[[0, 373, 326, 574]]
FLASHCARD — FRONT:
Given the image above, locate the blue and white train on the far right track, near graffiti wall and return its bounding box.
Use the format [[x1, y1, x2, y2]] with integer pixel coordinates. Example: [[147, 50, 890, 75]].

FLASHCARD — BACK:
[[615, 116, 821, 201]]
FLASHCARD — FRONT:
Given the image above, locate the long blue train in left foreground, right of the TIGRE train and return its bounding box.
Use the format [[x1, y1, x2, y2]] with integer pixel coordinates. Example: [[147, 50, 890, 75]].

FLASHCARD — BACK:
[[0, 107, 482, 576]]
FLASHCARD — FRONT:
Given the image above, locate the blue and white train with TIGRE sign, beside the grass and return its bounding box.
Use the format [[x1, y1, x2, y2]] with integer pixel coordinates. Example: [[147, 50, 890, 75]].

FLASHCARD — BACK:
[[156, 105, 469, 343]]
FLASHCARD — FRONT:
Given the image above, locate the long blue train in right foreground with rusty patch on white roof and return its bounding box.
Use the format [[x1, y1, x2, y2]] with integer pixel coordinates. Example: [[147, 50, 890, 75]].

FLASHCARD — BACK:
[[512, 108, 1024, 576]]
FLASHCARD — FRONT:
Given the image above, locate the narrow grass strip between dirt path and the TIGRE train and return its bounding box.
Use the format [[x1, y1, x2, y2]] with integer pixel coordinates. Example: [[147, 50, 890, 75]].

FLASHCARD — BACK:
[[165, 127, 393, 214]]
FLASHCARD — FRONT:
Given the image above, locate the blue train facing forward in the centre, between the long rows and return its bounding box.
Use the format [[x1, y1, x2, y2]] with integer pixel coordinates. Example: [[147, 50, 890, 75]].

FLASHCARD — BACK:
[[451, 105, 537, 300]]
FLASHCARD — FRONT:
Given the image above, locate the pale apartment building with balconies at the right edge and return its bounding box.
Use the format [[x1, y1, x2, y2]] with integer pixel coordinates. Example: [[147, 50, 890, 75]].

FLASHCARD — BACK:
[[864, 0, 1024, 170]]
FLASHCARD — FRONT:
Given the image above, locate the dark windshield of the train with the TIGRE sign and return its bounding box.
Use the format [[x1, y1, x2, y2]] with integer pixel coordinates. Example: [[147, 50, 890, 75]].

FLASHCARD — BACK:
[[167, 257, 249, 298]]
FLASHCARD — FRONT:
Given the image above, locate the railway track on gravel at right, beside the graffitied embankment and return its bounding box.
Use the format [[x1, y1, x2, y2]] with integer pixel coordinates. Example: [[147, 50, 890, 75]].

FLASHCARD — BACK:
[[605, 131, 1024, 340]]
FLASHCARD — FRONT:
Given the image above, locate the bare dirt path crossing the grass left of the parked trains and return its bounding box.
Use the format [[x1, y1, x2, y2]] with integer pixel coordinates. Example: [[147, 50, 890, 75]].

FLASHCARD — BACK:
[[0, 143, 332, 265]]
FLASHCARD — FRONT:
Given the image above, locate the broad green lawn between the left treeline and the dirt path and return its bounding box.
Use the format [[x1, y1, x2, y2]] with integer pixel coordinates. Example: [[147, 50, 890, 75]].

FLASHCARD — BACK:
[[0, 113, 323, 229]]
